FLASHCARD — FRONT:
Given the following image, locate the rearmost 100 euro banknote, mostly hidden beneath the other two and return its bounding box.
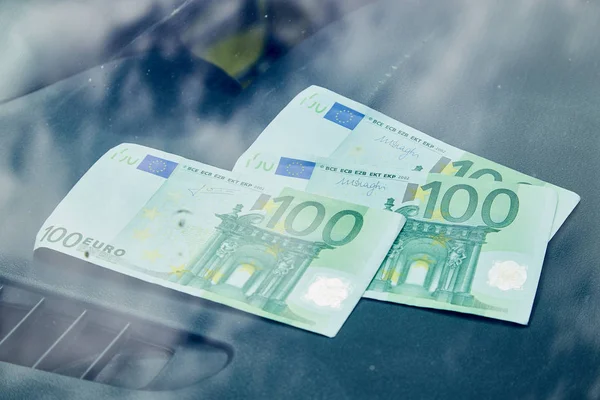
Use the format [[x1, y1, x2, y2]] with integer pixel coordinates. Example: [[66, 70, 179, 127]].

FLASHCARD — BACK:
[[234, 86, 579, 235]]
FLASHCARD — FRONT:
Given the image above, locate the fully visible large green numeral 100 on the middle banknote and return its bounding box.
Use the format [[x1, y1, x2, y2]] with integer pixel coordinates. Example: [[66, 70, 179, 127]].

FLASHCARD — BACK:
[[421, 181, 519, 229]]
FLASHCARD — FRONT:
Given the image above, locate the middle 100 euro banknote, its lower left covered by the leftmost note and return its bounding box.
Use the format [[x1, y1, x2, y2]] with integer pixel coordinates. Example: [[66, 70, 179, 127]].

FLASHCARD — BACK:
[[238, 154, 557, 324]]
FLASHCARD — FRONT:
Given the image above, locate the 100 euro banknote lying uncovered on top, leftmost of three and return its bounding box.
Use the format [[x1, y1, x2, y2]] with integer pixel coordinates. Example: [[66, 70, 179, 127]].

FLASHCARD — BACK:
[[35, 144, 406, 337]]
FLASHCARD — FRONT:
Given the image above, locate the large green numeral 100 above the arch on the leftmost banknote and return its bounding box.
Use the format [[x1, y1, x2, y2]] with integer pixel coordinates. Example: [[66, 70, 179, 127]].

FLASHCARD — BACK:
[[267, 196, 364, 246]]
